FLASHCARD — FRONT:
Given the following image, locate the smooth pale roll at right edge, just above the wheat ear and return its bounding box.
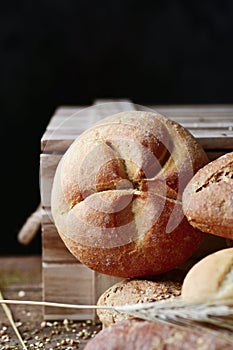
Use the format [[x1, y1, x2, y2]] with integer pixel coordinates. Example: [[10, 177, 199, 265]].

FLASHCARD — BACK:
[[181, 248, 233, 304]]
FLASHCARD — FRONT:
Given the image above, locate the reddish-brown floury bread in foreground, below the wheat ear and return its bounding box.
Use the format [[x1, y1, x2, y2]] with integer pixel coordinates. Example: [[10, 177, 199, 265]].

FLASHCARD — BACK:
[[84, 319, 232, 350]]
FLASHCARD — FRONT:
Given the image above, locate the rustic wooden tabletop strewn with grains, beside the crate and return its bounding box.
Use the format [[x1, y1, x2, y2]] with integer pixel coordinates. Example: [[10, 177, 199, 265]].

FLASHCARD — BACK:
[[0, 256, 101, 350]]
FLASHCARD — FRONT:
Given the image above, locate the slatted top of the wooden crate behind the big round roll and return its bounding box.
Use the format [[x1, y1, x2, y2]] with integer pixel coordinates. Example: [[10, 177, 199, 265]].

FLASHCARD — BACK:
[[41, 102, 233, 153]]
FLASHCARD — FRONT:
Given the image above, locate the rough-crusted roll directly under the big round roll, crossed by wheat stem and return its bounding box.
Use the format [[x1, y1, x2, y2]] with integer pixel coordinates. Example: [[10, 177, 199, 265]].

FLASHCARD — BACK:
[[97, 279, 182, 327]]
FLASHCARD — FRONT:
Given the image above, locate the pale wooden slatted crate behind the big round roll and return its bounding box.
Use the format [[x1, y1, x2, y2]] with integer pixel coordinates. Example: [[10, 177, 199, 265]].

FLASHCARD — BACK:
[[40, 100, 233, 320]]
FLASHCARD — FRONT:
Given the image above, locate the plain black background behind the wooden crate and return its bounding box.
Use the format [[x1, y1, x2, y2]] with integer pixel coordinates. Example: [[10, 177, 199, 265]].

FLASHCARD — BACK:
[[0, 0, 233, 254]]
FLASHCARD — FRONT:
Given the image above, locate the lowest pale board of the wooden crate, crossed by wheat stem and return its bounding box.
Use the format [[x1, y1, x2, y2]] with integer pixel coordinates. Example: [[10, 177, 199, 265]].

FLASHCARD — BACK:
[[42, 262, 122, 320]]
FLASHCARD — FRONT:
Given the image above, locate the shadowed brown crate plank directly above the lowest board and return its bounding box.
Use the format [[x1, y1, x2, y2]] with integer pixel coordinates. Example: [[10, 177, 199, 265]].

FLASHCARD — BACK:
[[42, 224, 75, 263]]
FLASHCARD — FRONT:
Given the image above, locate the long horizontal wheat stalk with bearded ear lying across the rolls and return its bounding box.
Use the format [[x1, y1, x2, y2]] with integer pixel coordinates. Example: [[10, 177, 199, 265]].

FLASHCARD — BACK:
[[0, 297, 233, 344]]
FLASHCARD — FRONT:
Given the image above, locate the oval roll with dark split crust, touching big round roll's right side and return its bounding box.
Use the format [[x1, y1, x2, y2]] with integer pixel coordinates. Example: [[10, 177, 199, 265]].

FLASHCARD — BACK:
[[183, 152, 233, 239]]
